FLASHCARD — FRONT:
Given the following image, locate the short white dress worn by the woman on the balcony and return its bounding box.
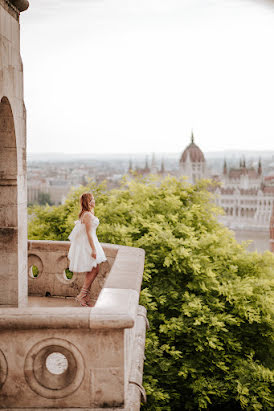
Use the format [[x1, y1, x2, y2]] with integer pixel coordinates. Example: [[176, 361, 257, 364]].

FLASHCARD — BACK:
[[68, 216, 107, 273]]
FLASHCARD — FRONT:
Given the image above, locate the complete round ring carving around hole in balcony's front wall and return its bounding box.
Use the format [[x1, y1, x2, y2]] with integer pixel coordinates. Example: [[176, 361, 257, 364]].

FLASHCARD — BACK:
[[24, 338, 85, 399]]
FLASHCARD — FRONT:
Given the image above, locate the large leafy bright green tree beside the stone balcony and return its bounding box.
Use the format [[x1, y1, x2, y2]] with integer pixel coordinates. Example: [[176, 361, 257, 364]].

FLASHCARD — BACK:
[[29, 178, 274, 411]]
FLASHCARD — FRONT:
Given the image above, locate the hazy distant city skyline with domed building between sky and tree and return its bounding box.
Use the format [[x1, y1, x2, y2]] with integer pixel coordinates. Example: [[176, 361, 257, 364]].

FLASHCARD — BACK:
[[28, 133, 274, 252]]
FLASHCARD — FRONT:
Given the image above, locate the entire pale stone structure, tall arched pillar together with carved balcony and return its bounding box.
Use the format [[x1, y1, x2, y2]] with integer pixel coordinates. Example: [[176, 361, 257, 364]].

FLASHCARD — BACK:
[[0, 0, 147, 411]]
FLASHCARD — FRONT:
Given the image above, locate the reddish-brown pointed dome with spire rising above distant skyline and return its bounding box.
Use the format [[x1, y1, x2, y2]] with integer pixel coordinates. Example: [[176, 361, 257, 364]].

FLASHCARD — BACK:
[[179, 132, 208, 184]]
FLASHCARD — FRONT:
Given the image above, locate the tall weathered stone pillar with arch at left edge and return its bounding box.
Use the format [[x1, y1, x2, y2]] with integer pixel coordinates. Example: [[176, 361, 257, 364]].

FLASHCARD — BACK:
[[0, 0, 28, 307]]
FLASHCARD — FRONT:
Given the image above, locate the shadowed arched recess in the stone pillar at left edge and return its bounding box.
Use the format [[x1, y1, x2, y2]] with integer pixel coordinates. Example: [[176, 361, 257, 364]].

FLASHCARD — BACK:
[[0, 97, 18, 305]]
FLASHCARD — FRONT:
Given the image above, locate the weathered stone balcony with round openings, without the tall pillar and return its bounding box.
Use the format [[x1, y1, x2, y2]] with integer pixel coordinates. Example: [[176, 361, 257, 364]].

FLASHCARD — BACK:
[[0, 241, 147, 410]]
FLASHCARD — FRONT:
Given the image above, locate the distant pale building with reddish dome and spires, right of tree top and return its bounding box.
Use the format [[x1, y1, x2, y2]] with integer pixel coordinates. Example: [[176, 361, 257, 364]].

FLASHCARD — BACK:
[[179, 133, 274, 251]]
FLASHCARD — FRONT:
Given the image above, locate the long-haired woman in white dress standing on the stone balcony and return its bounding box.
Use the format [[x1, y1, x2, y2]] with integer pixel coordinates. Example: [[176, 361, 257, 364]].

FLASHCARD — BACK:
[[68, 193, 106, 307]]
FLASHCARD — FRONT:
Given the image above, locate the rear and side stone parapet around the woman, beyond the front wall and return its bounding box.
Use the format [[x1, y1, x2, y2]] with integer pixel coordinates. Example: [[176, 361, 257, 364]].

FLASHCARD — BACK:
[[28, 240, 144, 304]]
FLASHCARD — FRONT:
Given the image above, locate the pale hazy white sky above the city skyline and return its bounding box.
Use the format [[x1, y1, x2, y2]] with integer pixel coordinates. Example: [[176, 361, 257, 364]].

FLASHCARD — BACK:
[[21, 0, 274, 153]]
